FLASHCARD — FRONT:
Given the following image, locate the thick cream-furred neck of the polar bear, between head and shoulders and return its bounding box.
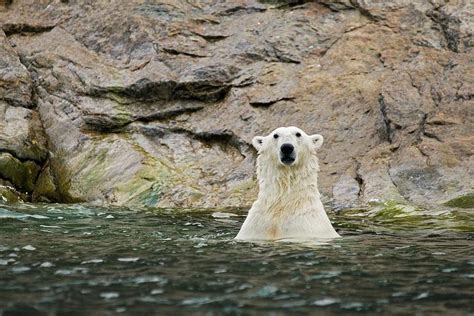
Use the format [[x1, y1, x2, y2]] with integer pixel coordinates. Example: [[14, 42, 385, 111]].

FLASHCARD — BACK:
[[257, 154, 320, 203]]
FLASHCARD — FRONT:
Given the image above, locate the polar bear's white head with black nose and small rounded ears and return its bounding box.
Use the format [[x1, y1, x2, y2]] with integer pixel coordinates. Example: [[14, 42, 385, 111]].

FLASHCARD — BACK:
[[252, 126, 324, 167]]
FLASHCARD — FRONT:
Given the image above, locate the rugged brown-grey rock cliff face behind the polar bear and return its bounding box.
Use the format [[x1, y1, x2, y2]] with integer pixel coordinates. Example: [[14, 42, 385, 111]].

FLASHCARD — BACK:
[[0, 0, 474, 207]]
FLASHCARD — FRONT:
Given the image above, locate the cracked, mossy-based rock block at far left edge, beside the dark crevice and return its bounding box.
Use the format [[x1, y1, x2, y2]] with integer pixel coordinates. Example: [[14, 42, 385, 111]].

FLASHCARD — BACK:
[[0, 31, 48, 200]]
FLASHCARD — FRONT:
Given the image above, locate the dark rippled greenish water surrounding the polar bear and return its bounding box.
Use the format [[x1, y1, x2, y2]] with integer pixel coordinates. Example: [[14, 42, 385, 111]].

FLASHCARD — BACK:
[[0, 205, 474, 315]]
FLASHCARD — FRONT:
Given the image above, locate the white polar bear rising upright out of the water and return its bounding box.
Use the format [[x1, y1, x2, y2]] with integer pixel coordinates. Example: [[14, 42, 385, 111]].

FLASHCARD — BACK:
[[235, 126, 340, 240]]
